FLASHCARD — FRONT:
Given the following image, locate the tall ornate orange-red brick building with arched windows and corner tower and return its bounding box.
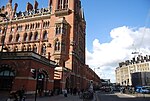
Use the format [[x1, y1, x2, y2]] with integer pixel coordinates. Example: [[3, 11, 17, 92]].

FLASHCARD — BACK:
[[0, 0, 100, 93]]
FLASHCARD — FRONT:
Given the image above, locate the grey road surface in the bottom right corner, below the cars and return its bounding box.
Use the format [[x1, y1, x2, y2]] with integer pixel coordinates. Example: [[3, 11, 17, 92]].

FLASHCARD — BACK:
[[97, 92, 150, 101]]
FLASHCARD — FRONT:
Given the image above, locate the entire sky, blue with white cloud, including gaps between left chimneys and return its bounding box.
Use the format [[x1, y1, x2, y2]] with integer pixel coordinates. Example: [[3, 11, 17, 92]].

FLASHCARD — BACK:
[[0, 0, 150, 82]]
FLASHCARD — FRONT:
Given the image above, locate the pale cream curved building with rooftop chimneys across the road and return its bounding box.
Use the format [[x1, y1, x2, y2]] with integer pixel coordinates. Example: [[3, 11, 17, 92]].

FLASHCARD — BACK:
[[115, 55, 150, 86]]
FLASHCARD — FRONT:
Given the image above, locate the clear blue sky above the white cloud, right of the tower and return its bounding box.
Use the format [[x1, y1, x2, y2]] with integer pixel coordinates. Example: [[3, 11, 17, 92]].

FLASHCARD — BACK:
[[82, 0, 150, 49]]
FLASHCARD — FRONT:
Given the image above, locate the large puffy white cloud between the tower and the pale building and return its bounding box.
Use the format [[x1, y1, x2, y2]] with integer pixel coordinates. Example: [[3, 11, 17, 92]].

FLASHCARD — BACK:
[[86, 26, 150, 82]]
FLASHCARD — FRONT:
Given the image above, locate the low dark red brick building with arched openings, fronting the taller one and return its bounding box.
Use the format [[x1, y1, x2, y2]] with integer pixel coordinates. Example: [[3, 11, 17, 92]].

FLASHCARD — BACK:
[[0, 52, 55, 93]]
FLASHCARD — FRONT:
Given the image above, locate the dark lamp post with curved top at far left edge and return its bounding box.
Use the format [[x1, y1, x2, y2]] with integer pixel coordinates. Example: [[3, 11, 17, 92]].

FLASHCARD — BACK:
[[0, 13, 8, 59]]
